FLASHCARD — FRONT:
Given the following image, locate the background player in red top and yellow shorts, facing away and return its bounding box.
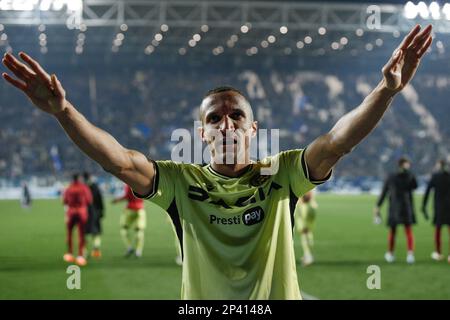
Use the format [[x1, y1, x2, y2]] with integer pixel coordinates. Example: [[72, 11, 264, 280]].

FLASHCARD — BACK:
[[113, 185, 146, 258]]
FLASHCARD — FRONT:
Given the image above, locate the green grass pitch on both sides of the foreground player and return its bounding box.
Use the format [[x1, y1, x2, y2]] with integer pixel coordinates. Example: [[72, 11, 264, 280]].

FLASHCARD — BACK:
[[0, 194, 450, 299]]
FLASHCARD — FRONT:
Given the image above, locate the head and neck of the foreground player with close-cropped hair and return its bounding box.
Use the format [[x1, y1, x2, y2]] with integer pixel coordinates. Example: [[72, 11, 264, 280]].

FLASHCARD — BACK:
[[200, 91, 257, 164]]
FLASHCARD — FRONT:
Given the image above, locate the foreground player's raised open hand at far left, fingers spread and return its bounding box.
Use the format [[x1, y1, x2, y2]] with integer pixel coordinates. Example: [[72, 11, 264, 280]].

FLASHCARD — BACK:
[[2, 52, 67, 114]]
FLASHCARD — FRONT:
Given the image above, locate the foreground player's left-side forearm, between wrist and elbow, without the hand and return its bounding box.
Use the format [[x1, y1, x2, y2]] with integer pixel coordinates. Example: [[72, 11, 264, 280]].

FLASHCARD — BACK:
[[55, 102, 131, 174]]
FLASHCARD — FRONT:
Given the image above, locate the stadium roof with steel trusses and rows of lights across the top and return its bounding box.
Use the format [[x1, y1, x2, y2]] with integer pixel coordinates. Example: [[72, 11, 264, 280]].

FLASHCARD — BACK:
[[0, 0, 450, 64]]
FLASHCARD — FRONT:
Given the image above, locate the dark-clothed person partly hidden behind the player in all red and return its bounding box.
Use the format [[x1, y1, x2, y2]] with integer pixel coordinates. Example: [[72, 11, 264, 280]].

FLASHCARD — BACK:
[[83, 172, 104, 258]]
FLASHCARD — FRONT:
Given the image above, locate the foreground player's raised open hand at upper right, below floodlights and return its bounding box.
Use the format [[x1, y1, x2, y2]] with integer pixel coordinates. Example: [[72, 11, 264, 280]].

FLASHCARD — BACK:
[[382, 25, 433, 93]]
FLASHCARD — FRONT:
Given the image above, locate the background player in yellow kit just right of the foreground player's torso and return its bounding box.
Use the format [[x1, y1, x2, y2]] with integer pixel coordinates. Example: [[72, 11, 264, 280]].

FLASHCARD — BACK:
[[295, 191, 318, 266]]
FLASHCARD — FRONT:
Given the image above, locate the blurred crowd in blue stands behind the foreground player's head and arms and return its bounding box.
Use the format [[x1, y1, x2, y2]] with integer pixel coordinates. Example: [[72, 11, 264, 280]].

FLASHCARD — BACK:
[[0, 60, 450, 186]]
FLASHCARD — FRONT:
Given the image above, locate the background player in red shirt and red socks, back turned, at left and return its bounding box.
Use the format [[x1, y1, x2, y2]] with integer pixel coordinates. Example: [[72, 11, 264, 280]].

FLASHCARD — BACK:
[[63, 174, 92, 266]]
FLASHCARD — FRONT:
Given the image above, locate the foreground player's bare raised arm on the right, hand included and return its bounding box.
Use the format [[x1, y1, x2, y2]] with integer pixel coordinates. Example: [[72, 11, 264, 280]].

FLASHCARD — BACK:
[[305, 25, 432, 180]]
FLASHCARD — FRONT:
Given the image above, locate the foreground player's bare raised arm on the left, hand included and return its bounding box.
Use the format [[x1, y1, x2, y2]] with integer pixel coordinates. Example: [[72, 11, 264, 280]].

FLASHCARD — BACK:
[[2, 52, 155, 194]]
